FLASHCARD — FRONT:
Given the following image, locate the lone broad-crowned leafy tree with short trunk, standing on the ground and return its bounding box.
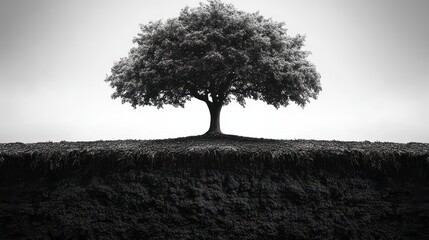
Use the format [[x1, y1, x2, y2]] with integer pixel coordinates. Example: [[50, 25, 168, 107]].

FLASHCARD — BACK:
[[105, 0, 321, 134]]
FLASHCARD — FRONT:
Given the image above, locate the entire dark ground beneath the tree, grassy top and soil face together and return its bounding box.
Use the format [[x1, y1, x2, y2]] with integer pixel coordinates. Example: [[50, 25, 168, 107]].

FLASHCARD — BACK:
[[0, 136, 429, 239]]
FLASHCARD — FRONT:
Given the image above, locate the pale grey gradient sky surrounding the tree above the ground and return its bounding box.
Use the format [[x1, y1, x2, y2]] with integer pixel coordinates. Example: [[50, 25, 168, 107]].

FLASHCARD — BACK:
[[0, 0, 429, 143]]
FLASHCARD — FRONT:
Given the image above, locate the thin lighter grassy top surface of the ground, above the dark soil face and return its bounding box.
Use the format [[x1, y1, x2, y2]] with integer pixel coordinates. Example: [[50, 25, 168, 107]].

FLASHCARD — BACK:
[[0, 135, 429, 155]]
